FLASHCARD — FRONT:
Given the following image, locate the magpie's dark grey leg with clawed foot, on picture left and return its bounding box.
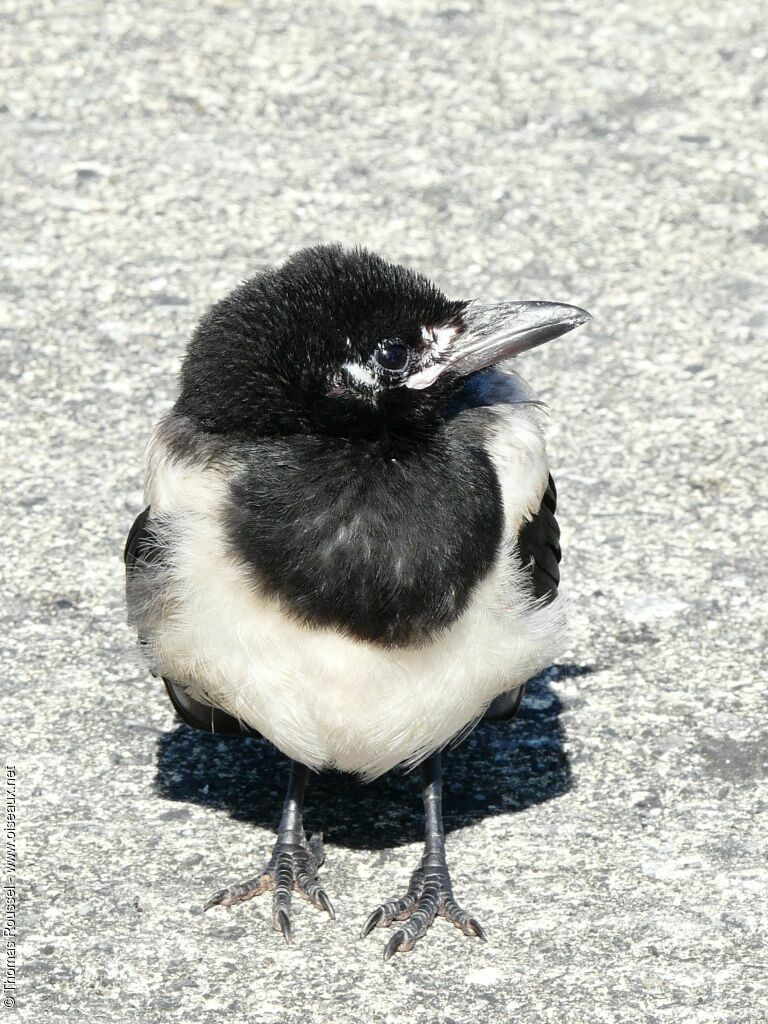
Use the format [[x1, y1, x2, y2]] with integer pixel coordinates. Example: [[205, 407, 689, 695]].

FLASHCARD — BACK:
[[205, 761, 336, 942]]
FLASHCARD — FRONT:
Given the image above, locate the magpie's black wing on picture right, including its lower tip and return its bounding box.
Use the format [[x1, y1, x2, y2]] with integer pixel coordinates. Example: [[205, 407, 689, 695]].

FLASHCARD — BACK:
[[483, 474, 560, 722]]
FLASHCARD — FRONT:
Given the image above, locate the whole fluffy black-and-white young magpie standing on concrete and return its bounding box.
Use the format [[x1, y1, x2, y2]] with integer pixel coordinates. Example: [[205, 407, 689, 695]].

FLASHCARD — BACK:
[[125, 245, 590, 959]]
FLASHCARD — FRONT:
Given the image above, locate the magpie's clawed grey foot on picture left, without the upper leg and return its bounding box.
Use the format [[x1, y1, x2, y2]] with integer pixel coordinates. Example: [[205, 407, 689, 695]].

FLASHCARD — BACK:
[[203, 834, 336, 942]]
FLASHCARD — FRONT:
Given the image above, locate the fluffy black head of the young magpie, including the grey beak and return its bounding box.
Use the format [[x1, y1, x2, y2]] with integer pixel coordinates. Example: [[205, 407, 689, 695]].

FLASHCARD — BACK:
[[176, 245, 589, 435]]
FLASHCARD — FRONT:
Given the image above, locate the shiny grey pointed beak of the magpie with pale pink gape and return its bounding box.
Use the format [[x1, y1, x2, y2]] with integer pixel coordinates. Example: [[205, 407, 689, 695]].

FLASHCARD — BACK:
[[406, 302, 592, 389]]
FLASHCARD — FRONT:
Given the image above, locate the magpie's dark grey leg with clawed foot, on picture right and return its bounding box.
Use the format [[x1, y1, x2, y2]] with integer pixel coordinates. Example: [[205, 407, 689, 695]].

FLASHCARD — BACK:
[[361, 753, 485, 961]]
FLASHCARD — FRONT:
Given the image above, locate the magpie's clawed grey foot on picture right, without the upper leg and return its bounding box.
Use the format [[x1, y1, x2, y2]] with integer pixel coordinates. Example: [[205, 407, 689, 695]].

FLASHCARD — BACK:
[[360, 863, 486, 961]]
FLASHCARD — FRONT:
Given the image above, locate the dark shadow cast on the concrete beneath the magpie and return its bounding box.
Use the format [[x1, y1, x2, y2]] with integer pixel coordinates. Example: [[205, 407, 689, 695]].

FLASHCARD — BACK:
[[155, 665, 595, 850]]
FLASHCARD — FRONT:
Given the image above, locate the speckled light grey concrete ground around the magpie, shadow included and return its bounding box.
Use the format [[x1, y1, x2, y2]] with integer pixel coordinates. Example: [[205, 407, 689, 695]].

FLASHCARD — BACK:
[[0, 0, 768, 1024]]
